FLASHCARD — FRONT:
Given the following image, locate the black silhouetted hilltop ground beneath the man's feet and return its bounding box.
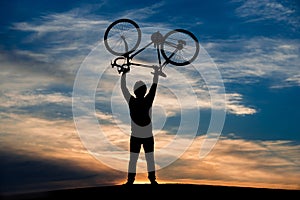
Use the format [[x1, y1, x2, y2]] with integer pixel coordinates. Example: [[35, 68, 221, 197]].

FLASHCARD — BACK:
[[2, 184, 300, 200]]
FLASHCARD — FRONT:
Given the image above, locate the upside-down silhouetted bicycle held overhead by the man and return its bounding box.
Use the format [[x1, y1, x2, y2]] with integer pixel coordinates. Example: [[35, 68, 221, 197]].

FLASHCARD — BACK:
[[104, 18, 199, 77]]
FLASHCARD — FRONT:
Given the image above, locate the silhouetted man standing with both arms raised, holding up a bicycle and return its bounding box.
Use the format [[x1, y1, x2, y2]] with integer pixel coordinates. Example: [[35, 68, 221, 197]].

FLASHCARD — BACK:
[[121, 67, 158, 185]]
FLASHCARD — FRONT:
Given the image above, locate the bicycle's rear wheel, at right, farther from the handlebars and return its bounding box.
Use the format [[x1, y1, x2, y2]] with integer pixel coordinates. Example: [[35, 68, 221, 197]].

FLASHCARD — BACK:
[[161, 29, 199, 66]]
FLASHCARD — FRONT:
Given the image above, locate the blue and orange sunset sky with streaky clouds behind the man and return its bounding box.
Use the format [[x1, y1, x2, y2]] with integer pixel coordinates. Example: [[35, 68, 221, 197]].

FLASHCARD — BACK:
[[0, 0, 300, 194]]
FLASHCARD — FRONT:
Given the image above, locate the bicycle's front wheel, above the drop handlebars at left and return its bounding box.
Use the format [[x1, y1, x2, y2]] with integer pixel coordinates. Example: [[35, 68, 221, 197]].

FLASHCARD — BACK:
[[104, 19, 142, 56]]
